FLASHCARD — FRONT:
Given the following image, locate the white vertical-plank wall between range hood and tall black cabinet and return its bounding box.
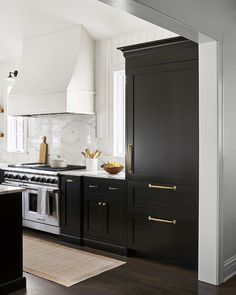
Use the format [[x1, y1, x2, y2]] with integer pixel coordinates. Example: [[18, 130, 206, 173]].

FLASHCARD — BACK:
[[95, 27, 176, 162]]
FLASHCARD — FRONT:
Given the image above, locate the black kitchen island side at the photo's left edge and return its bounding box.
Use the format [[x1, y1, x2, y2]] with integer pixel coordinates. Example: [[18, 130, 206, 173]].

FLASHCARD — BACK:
[[0, 193, 26, 294]]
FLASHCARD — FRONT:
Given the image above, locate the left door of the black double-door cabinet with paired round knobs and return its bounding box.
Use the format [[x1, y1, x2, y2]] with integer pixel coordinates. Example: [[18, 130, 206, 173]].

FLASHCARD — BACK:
[[84, 195, 104, 240]]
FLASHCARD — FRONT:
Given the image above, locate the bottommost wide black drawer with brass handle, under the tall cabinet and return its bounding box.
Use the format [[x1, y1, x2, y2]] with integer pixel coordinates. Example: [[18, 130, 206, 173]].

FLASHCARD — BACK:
[[128, 213, 198, 264]]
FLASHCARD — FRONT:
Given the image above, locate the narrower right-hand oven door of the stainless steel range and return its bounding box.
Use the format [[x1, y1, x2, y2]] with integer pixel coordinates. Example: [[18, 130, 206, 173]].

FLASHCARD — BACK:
[[45, 189, 60, 226]]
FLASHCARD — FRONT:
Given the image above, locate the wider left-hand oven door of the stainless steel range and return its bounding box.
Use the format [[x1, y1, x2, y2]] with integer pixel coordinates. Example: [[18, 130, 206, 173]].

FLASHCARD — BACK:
[[23, 188, 45, 223]]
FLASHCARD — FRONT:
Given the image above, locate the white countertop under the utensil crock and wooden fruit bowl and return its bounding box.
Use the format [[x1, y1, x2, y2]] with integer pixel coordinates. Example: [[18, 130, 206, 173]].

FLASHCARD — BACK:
[[59, 170, 125, 180]]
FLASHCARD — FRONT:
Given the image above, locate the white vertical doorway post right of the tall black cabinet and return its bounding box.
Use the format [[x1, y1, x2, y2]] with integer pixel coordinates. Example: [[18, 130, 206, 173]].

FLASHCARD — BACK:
[[198, 42, 219, 282]]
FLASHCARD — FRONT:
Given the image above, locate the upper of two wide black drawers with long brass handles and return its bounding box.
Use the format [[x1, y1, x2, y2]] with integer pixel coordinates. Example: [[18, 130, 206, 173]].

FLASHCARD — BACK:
[[128, 181, 198, 215]]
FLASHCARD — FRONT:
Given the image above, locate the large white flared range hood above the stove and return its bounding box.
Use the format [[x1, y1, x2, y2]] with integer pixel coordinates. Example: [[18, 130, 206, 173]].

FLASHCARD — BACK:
[[7, 25, 95, 116]]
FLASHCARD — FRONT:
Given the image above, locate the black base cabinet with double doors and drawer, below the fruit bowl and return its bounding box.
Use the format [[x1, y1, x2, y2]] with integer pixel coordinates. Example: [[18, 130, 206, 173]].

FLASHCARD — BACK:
[[83, 177, 127, 253]]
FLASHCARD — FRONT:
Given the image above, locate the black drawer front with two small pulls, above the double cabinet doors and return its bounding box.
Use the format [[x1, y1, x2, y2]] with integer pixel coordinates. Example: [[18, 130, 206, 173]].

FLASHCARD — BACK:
[[84, 177, 125, 195]]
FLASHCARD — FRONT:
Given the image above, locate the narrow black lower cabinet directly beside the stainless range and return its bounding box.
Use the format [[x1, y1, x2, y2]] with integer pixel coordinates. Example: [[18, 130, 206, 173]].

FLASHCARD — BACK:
[[60, 176, 82, 244]]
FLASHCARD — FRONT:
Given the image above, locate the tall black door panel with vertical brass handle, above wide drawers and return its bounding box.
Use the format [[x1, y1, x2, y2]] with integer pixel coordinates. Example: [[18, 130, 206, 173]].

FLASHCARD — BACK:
[[127, 61, 198, 183]]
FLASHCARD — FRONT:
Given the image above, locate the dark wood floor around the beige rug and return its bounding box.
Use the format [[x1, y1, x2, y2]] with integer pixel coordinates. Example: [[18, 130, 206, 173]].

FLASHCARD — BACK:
[[14, 232, 236, 295]]
